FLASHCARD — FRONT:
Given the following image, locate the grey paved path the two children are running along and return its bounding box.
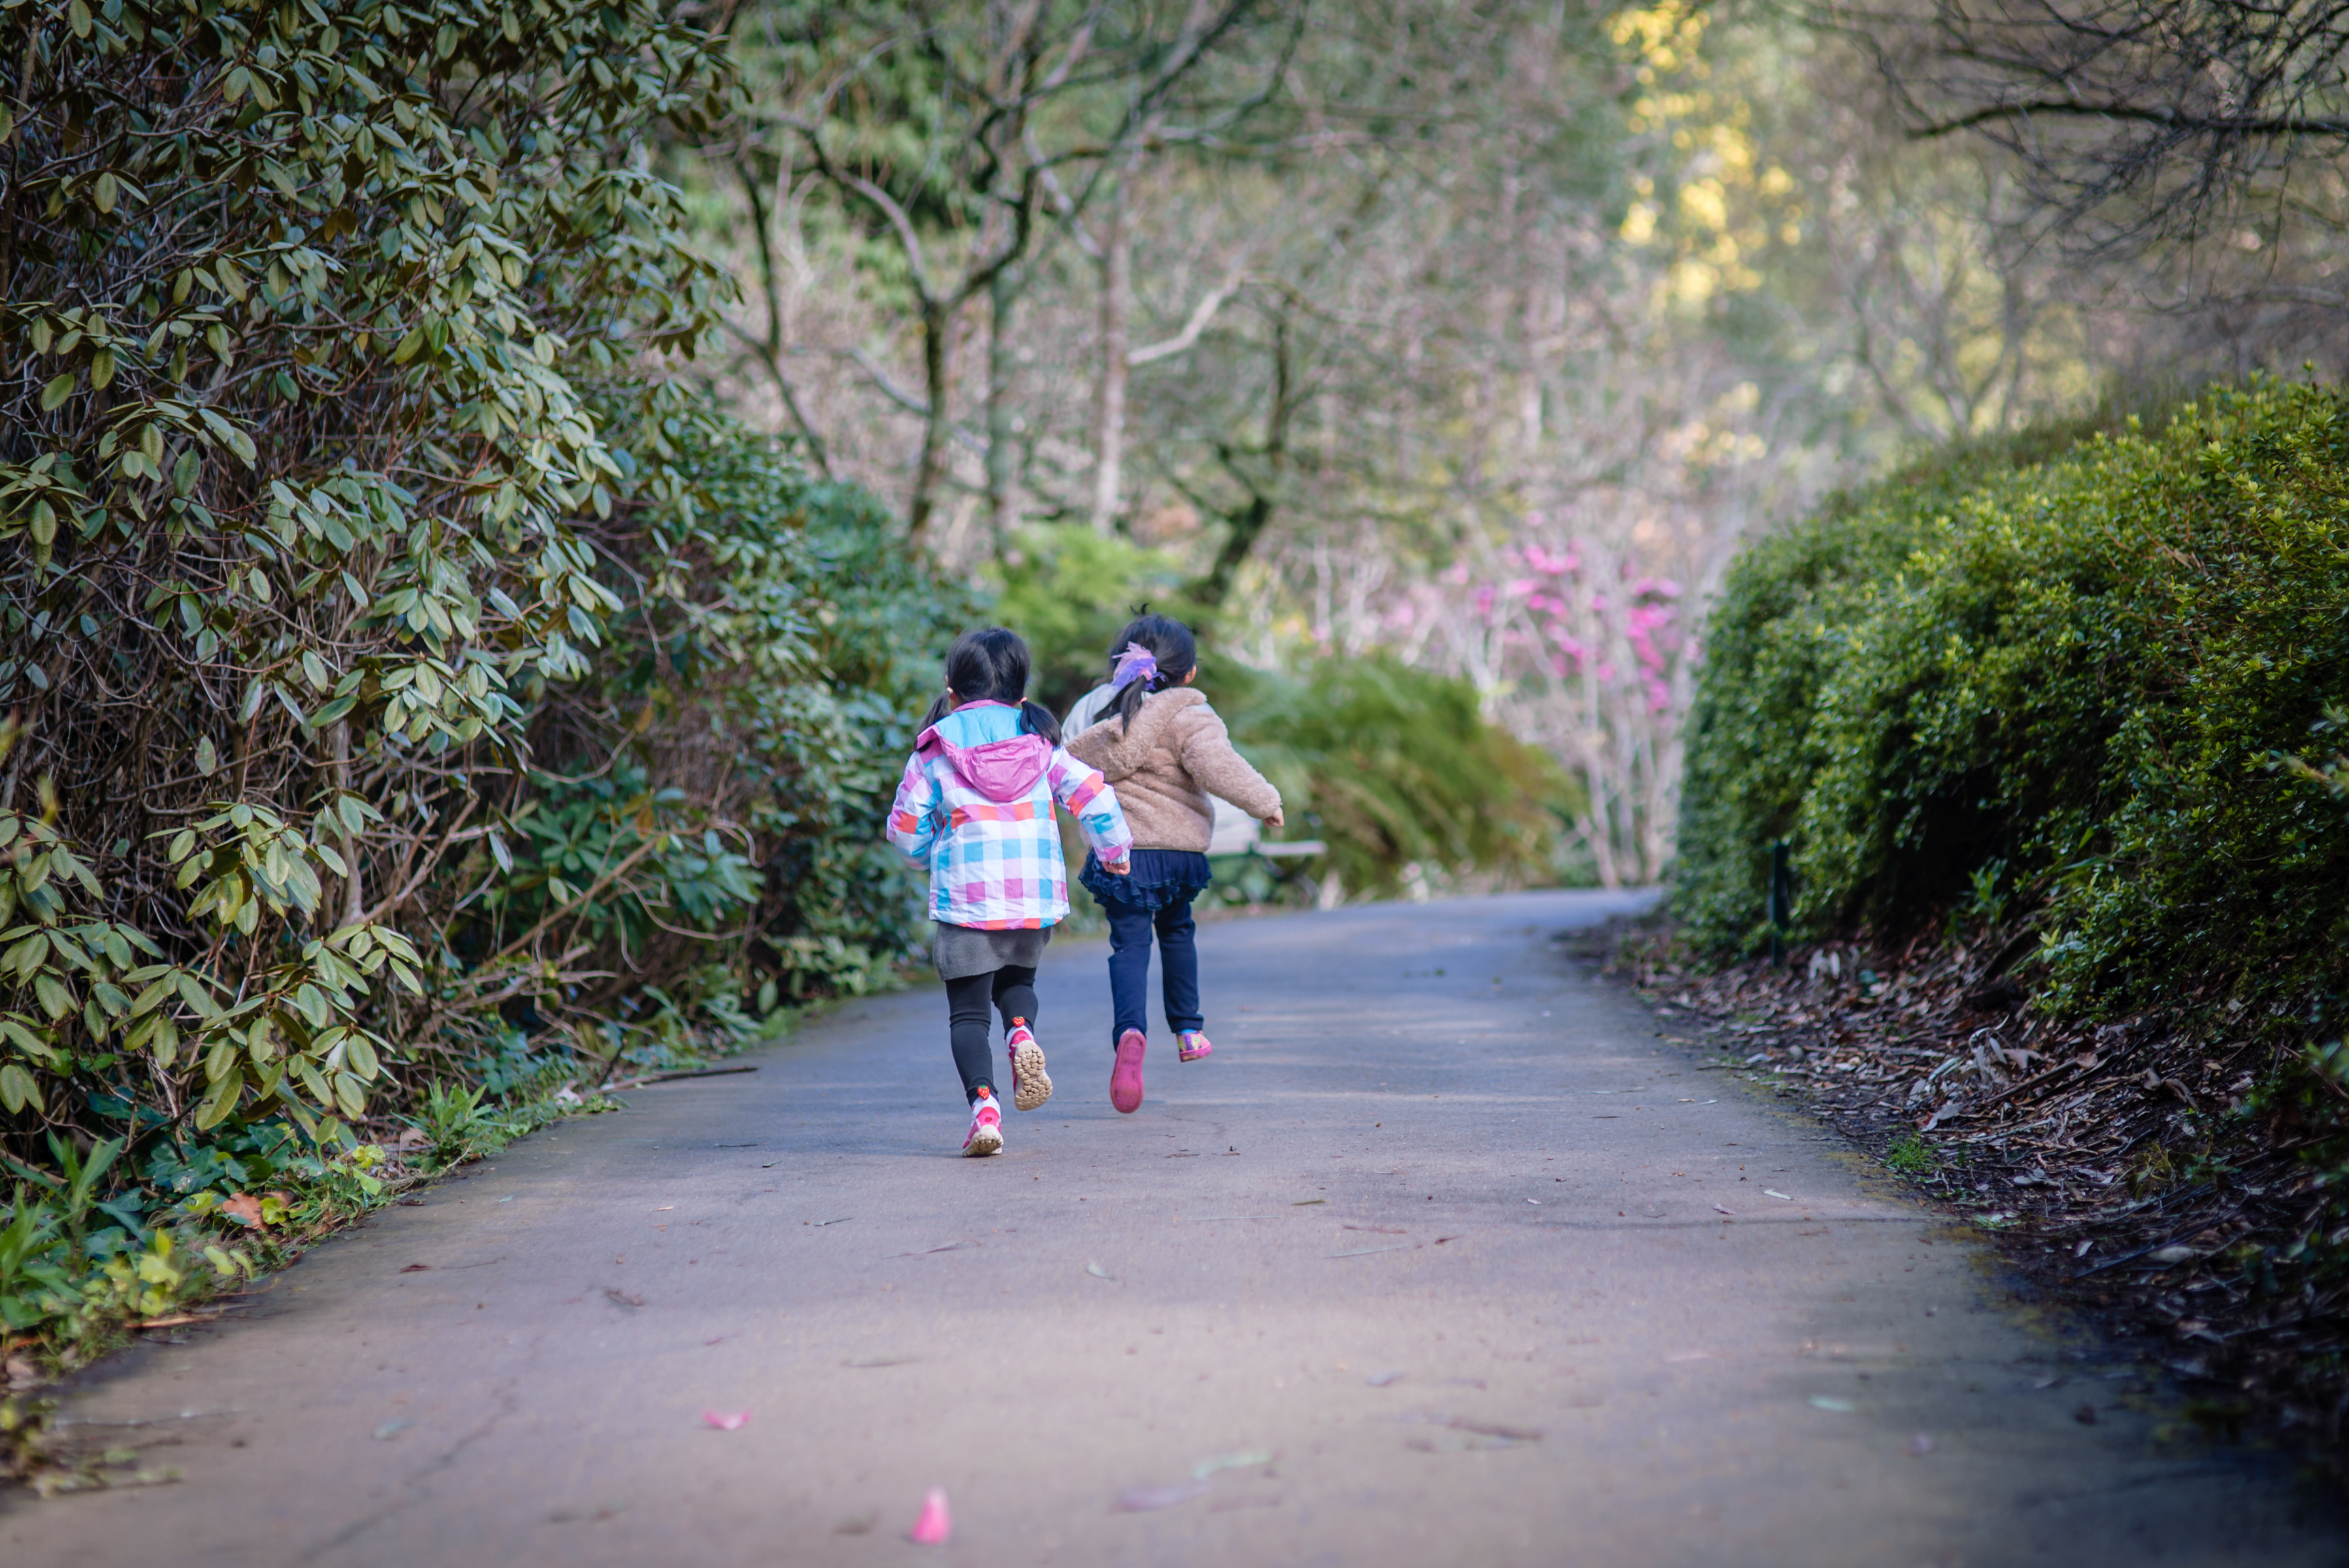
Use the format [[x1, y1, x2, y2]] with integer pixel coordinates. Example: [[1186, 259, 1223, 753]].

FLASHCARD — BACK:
[[0, 894, 2344, 1568]]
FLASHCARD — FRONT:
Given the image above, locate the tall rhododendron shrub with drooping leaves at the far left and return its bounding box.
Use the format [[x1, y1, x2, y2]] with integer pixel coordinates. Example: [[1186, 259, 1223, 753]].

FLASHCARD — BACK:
[[0, 0, 726, 1132]]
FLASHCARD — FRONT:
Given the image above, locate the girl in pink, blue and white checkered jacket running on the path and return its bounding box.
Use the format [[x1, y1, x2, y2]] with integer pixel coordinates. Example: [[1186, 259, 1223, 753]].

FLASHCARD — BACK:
[[888, 627, 1134, 1155]]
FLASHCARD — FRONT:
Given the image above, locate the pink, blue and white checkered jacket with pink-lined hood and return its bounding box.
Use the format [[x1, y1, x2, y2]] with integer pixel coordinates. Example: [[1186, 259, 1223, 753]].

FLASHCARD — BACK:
[[888, 702, 1134, 932]]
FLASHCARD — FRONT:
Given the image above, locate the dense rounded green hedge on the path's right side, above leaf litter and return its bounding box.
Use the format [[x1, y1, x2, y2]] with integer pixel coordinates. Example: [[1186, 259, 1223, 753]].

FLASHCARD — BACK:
[[1677, 383, 2349, 1009]]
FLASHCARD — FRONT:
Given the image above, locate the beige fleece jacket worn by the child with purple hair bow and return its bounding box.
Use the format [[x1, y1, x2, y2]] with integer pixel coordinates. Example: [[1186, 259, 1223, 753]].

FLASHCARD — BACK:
[[1069, 685, 1280, 850]]
